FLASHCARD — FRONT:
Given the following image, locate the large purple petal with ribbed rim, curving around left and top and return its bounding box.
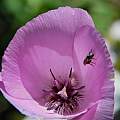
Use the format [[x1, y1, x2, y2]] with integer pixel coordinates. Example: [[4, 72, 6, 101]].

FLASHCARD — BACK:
[[0, 7, 94, 117]]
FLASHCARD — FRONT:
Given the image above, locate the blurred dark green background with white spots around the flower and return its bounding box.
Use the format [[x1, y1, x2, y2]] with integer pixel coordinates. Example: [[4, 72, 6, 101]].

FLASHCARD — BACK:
[[0, 0, 120, 120]]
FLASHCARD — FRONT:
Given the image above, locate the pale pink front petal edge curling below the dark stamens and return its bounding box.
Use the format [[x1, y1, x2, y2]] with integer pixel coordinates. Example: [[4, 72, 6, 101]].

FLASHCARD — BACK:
[[1, 86, 97, 120]]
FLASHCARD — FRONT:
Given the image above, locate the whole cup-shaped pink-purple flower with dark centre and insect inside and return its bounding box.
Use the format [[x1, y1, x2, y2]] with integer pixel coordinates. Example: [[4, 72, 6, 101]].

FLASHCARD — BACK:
[[0, 7, 114, 120]]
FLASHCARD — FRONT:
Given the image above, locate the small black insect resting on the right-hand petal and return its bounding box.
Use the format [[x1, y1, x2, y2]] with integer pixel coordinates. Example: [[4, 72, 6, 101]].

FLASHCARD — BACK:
[[83, 49, 95, 66]]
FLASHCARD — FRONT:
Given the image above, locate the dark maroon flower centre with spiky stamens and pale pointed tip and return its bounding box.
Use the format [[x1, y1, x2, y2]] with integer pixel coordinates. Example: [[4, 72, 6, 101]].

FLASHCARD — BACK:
[[44, 68, 85, 115]]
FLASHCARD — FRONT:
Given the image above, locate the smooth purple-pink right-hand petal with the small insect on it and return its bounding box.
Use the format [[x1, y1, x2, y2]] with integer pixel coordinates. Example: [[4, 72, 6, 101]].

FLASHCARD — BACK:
[[74, 26, 113, 102]]
